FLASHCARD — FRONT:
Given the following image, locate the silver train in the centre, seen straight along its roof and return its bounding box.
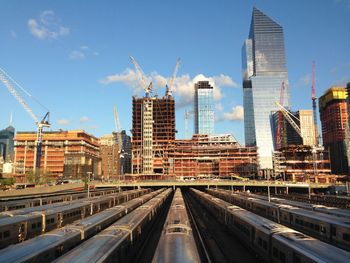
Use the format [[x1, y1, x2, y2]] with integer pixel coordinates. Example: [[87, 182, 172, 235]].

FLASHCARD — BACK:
[[152, 188, 201, 263]]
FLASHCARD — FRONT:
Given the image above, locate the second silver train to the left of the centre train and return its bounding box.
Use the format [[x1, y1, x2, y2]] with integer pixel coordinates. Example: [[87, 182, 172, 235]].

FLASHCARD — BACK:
[[0, 189, 165, 262]]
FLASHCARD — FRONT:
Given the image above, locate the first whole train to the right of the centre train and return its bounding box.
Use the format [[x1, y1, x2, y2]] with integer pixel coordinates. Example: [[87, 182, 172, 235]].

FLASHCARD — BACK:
[[190, 189, 350, 263]]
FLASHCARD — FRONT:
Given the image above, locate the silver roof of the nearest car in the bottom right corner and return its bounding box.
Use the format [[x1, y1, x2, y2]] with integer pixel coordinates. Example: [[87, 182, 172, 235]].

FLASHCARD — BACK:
[[274, 231, 350, 263]]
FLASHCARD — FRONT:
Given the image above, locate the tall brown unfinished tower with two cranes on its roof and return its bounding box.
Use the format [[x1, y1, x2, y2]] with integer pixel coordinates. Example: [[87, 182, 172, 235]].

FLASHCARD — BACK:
[[132, 96, 176, 175]]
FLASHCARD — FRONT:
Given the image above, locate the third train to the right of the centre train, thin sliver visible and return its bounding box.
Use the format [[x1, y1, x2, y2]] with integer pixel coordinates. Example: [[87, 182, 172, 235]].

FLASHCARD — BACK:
[[238, 192, 350, 218]]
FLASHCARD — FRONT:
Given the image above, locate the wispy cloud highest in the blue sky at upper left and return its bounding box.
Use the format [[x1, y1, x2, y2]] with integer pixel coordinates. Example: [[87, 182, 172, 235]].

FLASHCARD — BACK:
[[28, 10, 70, 39]]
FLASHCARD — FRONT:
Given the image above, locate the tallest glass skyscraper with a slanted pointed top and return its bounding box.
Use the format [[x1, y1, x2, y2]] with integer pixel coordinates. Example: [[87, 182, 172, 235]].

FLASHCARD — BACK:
[[242, 8, 289, 171]]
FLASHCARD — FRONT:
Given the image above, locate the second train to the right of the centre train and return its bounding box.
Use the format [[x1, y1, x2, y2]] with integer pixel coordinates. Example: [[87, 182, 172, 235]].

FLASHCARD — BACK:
[[208, 189, 350, 253]]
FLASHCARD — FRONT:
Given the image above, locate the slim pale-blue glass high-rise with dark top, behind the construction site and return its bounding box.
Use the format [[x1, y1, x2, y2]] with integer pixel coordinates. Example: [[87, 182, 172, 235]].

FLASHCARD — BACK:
[[194, 81, 214, 134]]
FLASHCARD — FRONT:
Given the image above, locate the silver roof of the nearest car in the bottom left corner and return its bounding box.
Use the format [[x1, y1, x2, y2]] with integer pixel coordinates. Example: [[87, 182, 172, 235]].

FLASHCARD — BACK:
[[0, 229, 80, 262]]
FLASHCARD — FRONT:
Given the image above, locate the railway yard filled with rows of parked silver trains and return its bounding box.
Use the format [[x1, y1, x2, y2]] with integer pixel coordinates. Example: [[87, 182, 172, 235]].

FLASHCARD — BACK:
[[0, 187, 350, 263]]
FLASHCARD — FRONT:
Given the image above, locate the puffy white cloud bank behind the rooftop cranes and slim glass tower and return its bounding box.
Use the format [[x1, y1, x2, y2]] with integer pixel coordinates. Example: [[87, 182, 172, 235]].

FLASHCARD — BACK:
[[100, 68, 237, 107]]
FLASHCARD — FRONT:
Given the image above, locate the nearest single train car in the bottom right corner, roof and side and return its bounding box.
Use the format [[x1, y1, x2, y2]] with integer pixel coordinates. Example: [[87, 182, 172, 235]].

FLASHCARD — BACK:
[[270, 230, 350, 263]]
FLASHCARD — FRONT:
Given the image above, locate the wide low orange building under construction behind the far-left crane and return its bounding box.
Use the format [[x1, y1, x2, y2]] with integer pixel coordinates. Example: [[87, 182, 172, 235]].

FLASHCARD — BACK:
[[14, 130, 101, 181]]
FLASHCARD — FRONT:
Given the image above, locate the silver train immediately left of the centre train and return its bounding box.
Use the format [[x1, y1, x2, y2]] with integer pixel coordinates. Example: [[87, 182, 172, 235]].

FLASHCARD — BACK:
[[55, 189, 172, 262]]
